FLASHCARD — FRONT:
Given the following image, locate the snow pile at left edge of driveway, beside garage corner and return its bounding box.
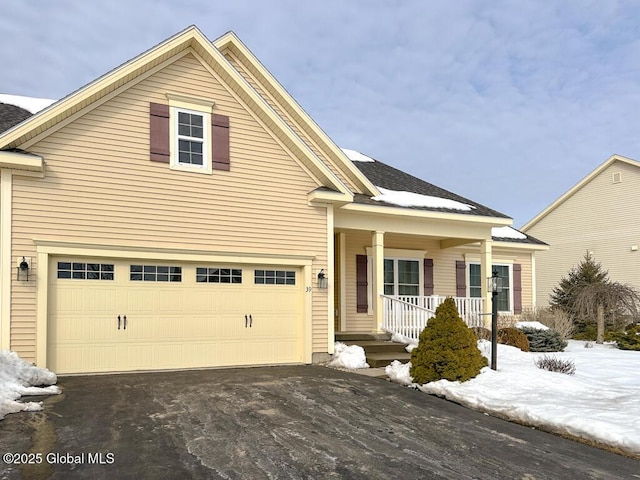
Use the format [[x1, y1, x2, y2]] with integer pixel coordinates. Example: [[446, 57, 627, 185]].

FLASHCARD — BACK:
[[0, 350, 60, 420]]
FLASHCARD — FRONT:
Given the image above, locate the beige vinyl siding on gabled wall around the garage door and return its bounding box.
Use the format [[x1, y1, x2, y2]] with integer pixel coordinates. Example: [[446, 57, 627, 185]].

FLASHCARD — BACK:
[[12, 55, 327, 359]]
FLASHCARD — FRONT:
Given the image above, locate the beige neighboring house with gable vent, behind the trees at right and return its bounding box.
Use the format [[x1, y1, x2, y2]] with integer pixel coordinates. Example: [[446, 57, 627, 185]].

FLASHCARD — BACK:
[[522, 155, 640, 305]]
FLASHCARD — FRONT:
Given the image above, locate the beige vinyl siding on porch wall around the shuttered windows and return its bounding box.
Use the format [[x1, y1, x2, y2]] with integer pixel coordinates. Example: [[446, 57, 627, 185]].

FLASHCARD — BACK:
[[345, 232, 532, 331]]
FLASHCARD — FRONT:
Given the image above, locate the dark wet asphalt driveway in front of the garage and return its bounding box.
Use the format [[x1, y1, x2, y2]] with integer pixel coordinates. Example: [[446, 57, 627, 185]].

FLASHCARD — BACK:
[[0, 366, 640, 480]]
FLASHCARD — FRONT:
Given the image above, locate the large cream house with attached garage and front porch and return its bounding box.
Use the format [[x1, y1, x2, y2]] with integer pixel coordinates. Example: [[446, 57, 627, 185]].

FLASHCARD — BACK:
[[0, 27, 547, 373]]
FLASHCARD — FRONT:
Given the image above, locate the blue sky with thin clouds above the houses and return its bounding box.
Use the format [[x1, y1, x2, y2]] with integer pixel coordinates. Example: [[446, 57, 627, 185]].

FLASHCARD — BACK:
[[0, 0, 640, 227]]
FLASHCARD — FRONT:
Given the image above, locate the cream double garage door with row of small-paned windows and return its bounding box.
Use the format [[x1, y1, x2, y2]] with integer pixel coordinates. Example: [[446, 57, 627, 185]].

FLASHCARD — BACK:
[[47, 258, 304, 374]]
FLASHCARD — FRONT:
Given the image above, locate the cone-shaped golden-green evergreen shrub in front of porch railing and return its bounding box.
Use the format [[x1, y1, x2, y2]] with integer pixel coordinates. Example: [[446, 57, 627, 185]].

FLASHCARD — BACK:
[[410, 298, 487, 384]]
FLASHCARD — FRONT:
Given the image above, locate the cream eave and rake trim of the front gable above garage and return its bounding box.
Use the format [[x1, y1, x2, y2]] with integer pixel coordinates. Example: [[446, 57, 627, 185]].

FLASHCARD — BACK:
[[0, 26, 353, 201]]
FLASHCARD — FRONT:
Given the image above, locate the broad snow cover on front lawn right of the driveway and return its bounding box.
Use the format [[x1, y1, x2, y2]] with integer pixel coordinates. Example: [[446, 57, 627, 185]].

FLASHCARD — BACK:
[[386, 340, 640, 454]]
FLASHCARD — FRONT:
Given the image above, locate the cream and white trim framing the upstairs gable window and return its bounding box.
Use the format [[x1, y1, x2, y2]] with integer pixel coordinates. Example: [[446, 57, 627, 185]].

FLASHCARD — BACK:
[[167, 93, 215, 175]]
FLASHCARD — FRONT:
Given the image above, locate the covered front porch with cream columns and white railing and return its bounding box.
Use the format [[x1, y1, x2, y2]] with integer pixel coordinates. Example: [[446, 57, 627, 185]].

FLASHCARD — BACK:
[[333, 205, 504, 338]]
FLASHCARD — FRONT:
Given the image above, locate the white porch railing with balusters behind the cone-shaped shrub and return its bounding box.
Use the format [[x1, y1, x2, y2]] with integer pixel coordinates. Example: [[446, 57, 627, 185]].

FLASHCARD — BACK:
[[381, 295, 484, 340]]
